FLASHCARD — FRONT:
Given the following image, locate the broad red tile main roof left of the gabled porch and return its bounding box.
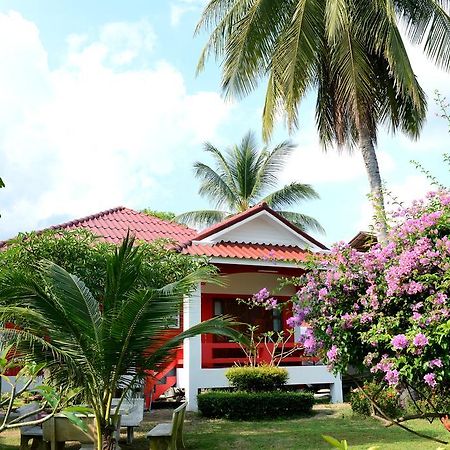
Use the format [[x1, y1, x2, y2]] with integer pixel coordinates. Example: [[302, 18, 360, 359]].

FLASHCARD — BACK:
[[51, 206, 197, 244]]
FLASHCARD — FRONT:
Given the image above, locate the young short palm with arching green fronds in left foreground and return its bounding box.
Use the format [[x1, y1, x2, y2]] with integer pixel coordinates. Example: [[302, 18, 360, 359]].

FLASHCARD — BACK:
[[0, 237, 239, 450]]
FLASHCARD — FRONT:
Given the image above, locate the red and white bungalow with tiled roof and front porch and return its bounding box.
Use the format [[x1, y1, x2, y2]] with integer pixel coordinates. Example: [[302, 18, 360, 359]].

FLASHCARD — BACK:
[[3, 203, 342, 411]]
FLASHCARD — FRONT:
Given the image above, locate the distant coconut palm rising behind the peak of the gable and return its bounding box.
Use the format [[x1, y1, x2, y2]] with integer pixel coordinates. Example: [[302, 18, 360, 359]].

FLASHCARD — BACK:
[[175, 132, 323, 232]]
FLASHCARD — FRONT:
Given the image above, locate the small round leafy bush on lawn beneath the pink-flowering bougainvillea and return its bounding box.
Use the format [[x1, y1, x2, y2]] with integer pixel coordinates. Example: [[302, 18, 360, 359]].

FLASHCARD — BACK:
[[350, 383, 402, 418]]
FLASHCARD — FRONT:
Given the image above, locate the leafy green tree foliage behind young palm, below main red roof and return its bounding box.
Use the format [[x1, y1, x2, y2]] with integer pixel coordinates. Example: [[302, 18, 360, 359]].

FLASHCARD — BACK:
[[0, 228, 206, 297]]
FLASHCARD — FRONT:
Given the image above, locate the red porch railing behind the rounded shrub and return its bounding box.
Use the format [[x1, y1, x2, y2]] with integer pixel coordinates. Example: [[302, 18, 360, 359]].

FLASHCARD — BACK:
[[202, 342, 319, 368]]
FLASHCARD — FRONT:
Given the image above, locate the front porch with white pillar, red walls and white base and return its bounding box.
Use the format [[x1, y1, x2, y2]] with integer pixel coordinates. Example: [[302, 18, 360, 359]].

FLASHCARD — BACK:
[[176, 266, 343, 411]]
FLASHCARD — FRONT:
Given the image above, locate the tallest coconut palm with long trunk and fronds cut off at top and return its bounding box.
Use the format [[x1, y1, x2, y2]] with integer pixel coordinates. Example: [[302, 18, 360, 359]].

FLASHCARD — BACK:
[[196, 0, 450, 239]]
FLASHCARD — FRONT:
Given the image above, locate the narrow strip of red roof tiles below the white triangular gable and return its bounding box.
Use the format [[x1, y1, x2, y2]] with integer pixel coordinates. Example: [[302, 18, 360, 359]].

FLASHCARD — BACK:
[[181, 242, 308, 261]]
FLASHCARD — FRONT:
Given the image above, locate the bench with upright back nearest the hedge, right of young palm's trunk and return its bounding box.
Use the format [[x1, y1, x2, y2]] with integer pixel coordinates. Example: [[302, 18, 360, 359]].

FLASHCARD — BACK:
[[147, 402, 187, 450]]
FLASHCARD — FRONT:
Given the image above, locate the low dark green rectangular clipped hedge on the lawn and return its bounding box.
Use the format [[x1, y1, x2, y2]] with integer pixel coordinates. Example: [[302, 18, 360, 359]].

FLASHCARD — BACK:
[[198, 391, 314, 420]]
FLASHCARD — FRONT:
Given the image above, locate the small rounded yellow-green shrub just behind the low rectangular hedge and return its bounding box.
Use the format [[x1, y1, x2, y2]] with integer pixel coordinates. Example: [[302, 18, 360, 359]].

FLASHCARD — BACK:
[[225, 366, 289, 392]]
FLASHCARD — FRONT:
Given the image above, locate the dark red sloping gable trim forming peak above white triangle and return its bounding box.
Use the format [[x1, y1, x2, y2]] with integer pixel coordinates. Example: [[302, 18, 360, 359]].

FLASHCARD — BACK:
[[190, 203, 328, 250]]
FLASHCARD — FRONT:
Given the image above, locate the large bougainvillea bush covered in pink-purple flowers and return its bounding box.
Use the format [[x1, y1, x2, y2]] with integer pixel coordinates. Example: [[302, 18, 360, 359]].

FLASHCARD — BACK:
[[289, 191, 450, 408]]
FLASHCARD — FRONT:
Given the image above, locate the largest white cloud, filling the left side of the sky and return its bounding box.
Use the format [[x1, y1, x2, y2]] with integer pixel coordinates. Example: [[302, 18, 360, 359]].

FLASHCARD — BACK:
[[0, 13, 230, 238]]
